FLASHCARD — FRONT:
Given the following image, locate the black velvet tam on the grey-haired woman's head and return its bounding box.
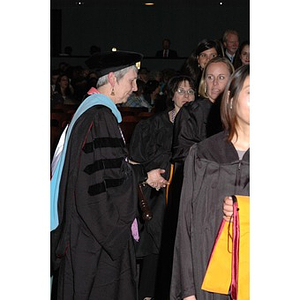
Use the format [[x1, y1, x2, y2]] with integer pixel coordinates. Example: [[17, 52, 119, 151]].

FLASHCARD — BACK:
[[85, 51, 143, 77]]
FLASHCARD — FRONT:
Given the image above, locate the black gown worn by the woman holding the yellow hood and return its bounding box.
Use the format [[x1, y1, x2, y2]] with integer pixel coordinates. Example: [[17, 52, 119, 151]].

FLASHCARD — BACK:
[[170, 132, 249, 300]]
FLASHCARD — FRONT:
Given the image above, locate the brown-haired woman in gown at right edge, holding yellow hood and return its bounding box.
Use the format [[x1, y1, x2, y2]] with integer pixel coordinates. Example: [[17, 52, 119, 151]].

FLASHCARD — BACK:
[[170, 65, 250, 300]]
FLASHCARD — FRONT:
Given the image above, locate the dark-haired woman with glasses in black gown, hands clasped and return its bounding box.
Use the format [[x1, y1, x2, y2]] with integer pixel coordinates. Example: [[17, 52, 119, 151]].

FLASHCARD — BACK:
[[129, 75, 195, 300]]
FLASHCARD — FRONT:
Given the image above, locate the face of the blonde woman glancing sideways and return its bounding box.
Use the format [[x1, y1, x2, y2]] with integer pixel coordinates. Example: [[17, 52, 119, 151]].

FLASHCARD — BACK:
[[205, 62, 230, 102]]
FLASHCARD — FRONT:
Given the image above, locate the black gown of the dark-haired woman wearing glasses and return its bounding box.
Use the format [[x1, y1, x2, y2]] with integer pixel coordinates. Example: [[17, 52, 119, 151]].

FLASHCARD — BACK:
[[129, 110, 173, 258]]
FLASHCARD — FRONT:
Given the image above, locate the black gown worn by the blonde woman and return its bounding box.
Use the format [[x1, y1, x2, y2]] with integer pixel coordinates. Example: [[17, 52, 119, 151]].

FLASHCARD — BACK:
[[157, 98, 222, 300]]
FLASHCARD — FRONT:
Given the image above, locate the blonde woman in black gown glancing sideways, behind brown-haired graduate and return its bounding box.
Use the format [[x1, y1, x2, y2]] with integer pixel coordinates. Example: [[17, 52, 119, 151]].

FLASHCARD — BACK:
[[155, 57, 234, 299]]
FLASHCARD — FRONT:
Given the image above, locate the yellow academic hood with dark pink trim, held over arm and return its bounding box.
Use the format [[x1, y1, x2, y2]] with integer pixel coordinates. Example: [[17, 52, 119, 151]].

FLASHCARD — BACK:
[[201, 196, 250, 300]]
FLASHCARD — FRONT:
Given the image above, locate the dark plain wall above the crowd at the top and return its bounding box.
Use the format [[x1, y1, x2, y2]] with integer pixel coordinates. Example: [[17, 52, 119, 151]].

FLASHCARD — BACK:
[[51, 0, 249, 67]]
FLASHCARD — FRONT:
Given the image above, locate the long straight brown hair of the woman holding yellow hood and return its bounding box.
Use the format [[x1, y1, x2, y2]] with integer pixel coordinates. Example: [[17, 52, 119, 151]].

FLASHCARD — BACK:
[[221, 65, 250, 141]]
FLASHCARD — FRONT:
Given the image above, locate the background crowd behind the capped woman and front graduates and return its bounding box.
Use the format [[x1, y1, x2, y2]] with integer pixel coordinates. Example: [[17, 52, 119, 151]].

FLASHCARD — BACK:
[[51, 30, 250, 111]]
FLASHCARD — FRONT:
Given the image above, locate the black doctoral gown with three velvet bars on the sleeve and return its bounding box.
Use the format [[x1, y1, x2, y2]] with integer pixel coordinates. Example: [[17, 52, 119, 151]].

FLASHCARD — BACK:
[[52, 105, 145, 300]]
